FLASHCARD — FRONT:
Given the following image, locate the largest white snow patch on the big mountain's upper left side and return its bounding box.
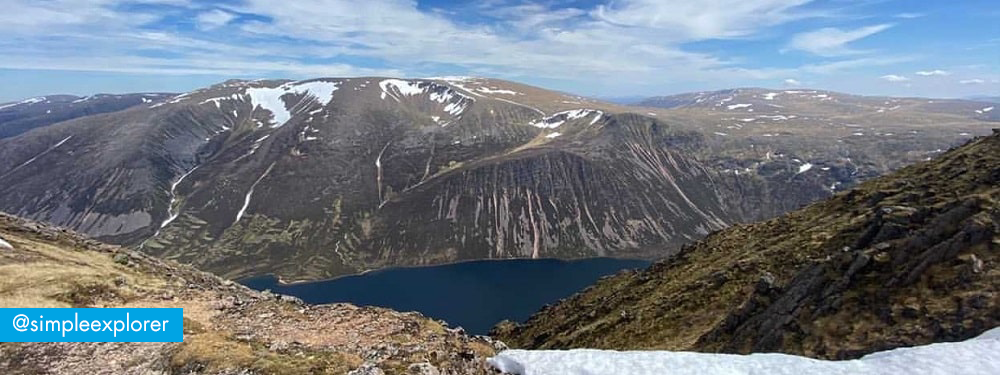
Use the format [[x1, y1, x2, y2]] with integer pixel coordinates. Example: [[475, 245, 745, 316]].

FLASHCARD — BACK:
[[245, 81, 340, 128]]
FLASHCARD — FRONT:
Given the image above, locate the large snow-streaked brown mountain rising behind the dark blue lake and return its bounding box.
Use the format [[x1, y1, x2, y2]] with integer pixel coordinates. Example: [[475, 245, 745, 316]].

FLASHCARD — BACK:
[[0, 77, 995, 280]]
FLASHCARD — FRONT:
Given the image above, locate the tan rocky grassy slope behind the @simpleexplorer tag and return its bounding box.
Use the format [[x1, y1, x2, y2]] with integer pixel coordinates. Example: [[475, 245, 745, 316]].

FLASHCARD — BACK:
[[0, 214, 502, 375]]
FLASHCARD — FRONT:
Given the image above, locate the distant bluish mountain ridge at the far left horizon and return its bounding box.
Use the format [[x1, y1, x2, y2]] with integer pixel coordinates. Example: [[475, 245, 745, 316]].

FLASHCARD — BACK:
[[0, 93, 176, 139]]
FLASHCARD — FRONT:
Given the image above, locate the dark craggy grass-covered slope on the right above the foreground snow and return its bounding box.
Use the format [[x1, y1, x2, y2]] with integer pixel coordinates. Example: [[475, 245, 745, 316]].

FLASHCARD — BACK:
[[495, 130, 1000, 359]]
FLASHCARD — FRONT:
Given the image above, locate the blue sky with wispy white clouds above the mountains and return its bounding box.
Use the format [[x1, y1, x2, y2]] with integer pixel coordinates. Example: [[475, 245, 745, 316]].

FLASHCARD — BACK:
[[0, 0, 1000, 101]]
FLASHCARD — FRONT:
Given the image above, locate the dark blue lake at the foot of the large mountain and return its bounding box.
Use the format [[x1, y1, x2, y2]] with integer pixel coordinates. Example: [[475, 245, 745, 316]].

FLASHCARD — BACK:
[[241, 258, 649, 335]]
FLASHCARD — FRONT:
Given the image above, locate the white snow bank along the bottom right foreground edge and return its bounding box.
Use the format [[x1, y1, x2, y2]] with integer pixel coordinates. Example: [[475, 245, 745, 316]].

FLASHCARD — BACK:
[[488, 328, 1000, 375]]
